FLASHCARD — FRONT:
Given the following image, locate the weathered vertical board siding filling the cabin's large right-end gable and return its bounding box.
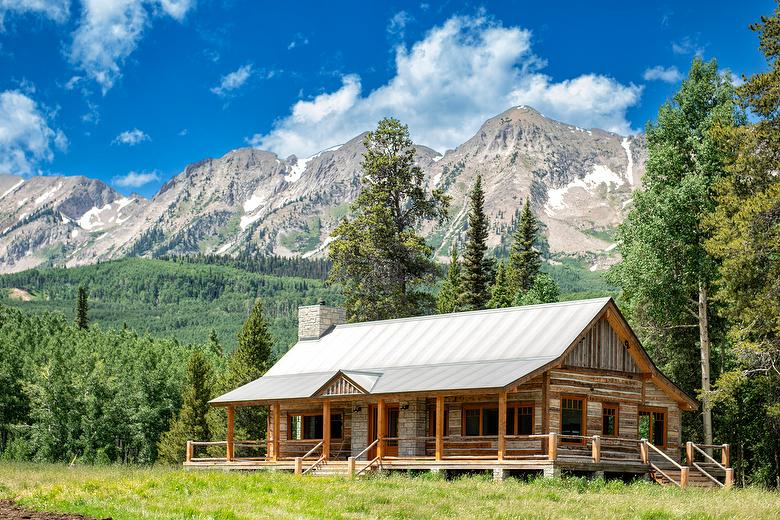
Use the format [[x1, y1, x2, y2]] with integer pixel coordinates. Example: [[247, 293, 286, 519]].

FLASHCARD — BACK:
[[563, 318, 639, 373]]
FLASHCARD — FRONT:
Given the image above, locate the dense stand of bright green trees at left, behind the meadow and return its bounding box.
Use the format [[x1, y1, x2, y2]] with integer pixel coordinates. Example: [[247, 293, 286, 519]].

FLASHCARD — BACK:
[[0, 306, 190, 463]]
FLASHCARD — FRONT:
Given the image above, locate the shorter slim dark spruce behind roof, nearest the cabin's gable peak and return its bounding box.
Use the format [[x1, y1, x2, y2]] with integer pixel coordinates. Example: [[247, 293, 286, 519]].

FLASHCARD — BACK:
[[509, 197, 542, 296]]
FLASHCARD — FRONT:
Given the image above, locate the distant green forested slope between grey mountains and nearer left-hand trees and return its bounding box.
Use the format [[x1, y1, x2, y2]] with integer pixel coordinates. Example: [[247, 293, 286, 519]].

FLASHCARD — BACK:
[[0, 257, 340, 353]]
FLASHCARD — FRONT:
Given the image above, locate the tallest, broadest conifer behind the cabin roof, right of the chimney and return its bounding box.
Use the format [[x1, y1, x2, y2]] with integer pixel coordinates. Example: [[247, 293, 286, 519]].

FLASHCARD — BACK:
[[328, 118, 449, 322]]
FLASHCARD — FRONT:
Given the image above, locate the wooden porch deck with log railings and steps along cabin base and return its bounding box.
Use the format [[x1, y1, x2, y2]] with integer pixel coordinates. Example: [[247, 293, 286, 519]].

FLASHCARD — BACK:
[[184, 433, 733, 487]]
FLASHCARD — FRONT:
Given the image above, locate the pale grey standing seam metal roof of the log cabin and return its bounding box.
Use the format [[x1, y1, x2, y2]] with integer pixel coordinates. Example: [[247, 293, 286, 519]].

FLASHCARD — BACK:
[[211, 298, 610, 403]]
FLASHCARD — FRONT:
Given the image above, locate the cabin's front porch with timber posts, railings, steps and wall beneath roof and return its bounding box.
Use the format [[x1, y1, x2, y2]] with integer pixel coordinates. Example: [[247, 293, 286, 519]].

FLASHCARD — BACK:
[[184, 390, 733, 487]]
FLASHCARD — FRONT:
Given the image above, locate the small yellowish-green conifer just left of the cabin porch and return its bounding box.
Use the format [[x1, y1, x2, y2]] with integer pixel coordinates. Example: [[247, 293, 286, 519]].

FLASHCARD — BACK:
[[157, 350, 214, 464]]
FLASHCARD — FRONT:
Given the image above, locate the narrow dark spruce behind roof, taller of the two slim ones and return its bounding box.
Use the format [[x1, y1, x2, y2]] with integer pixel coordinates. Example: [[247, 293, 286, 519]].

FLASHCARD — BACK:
[[460, 175, 491, 310]]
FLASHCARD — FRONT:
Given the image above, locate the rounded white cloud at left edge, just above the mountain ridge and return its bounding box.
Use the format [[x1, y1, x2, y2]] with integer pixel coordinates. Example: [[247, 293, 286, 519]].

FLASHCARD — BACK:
[[0, 90, 68, 175]]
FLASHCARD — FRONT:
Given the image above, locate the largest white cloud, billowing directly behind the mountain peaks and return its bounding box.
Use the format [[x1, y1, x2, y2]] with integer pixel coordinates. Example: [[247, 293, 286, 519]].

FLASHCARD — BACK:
[[247, 16, 642, 157]]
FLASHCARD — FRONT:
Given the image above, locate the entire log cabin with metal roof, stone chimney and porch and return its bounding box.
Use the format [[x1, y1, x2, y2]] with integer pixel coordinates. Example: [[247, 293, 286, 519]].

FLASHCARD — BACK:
[[185, 298, 732, 487]]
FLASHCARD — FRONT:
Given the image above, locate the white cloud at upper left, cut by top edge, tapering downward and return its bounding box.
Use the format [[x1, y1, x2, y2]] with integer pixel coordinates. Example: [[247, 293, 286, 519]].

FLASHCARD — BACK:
[[69, 0, 194, 94]]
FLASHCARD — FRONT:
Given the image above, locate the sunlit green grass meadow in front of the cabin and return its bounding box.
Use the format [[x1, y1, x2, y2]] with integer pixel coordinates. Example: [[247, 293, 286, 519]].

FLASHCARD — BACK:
[[0, 463, 780, 520]]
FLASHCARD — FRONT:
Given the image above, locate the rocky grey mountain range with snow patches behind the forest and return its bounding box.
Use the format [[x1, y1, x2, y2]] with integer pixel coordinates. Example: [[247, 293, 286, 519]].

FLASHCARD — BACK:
[[0, 106, 646, 273]]
